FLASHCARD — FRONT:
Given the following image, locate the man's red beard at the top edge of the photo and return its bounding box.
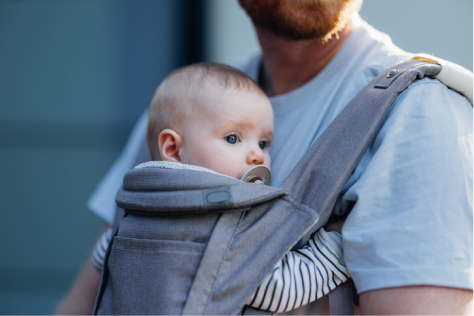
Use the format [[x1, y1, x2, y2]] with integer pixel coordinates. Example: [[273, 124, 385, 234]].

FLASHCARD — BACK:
[[239, 0, 362, 42]]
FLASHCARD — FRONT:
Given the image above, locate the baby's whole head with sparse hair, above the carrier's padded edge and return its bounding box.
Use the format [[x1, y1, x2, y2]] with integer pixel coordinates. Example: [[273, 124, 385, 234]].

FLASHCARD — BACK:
[[147, 63, 273, 179]]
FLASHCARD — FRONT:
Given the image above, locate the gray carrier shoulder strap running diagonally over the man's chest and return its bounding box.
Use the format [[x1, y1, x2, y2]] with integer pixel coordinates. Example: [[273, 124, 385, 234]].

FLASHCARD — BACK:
[[254, 60, 441, 316]]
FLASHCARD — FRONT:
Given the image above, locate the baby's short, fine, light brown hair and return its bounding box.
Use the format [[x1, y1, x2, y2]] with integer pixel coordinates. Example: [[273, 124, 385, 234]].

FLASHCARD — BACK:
[[147, 62, 265, 160]]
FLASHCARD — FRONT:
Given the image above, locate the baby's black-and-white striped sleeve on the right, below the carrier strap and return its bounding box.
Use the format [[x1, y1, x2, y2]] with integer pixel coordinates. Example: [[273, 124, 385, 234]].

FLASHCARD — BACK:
[[247, 228, 350, 313]]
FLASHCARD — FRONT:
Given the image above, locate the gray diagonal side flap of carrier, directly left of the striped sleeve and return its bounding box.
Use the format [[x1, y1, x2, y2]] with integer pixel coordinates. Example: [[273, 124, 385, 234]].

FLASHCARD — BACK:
[[190, 199, 318, 315]]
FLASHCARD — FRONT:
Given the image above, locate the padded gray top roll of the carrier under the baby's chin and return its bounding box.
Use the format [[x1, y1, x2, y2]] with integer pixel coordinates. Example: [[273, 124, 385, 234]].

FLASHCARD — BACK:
[[115, 168, 286, 213]]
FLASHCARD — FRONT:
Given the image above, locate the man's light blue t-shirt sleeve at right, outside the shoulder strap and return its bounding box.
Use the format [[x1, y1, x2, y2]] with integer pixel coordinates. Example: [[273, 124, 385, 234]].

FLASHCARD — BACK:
[[340, 79, 474, 292]]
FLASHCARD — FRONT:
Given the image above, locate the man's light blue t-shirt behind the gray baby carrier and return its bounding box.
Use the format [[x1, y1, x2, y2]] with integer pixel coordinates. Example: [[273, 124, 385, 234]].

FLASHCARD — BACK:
[[89, 16, 474, 292]]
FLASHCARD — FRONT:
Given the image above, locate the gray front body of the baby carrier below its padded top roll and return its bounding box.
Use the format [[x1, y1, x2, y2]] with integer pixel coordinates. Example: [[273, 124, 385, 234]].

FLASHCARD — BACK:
[[96, 178, 318, 315]]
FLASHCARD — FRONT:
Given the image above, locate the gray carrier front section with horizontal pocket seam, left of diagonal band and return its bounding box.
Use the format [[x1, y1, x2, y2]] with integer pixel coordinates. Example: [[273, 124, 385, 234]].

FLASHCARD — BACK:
[[107, 214, 218, 315]]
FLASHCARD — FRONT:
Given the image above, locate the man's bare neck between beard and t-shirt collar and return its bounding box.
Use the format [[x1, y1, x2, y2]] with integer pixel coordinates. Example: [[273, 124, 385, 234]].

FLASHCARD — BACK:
[[256, 25, 352, 96]]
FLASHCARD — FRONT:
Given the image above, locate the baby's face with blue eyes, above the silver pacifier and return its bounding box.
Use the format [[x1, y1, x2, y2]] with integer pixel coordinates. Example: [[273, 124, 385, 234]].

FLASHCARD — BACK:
[[180, 89, 273, 179]]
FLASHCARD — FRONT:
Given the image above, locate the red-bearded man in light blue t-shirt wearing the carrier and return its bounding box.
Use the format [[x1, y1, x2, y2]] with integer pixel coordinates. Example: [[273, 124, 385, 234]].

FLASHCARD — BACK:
[[57, 0, 474, 315]]
